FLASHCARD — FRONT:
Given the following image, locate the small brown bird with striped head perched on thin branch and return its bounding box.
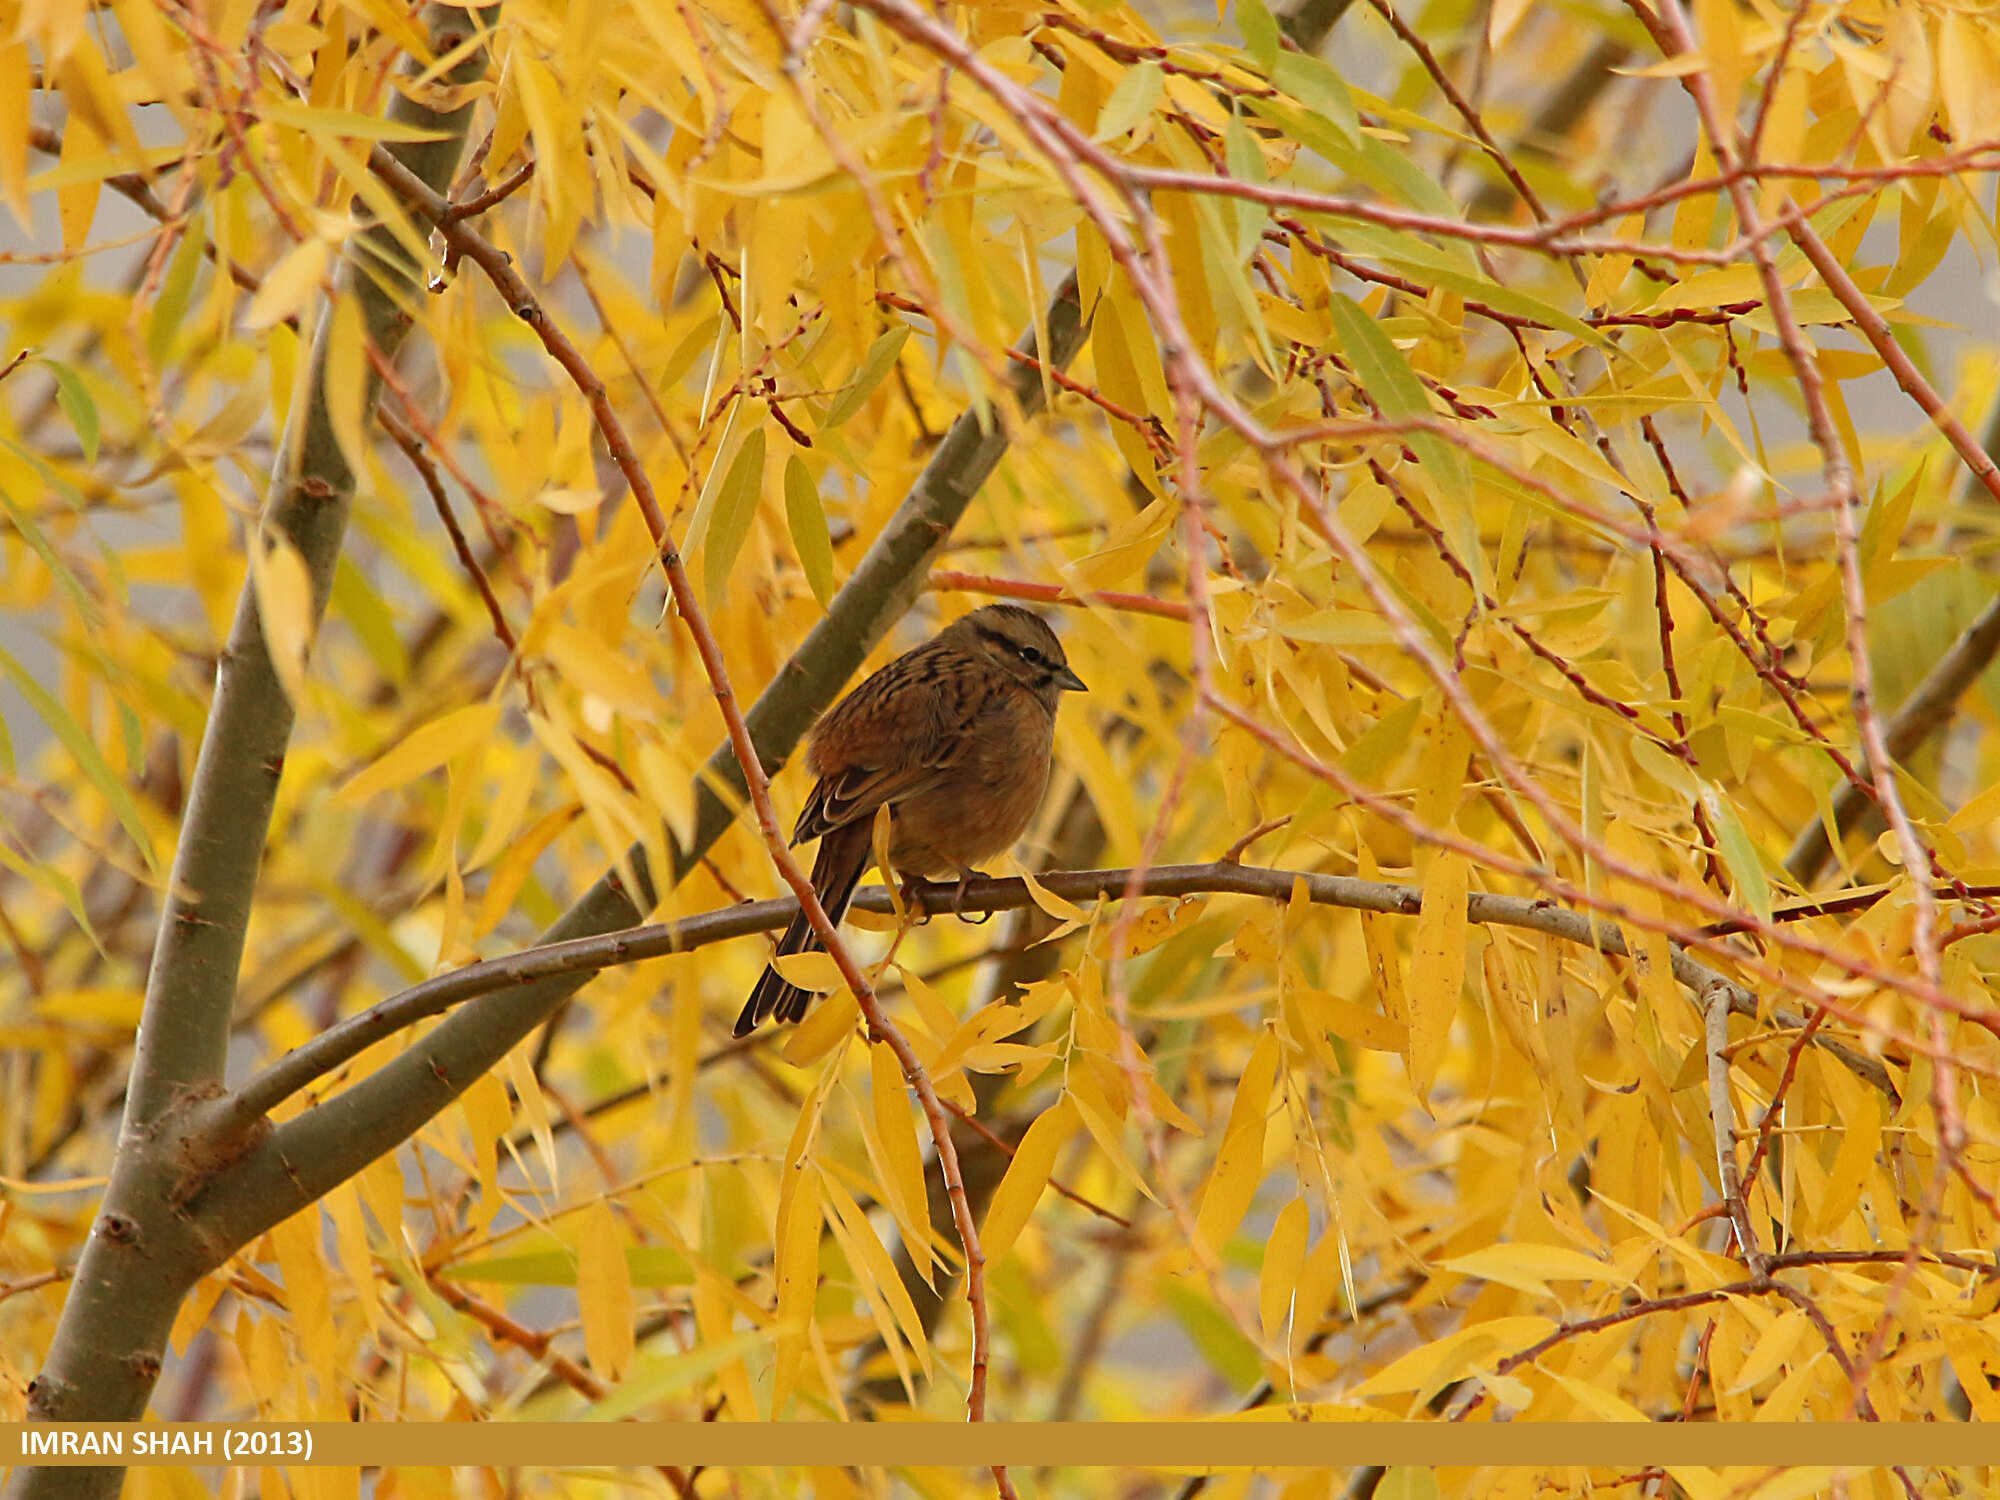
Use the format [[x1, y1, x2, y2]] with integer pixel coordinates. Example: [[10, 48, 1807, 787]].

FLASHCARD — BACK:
[[736, 604, 1088, 1036]]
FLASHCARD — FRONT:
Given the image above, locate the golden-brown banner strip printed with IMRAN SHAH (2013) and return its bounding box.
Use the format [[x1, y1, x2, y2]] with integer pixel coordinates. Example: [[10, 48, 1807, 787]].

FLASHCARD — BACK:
[[0, 1420, 2000, 1470]]
